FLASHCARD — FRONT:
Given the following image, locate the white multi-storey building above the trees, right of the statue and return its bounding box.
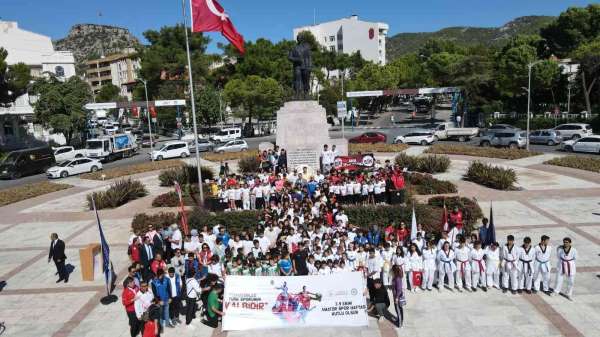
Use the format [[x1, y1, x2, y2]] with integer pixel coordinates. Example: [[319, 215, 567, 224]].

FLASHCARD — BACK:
[[294, 15, 389, 65]]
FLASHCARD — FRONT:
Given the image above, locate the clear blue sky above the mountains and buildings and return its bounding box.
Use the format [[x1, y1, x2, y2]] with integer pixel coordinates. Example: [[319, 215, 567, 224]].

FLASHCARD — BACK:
[[0, 0, 598, 52]]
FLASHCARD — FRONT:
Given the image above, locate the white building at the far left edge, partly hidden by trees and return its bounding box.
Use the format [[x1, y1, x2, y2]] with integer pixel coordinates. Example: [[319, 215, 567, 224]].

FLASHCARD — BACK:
[[0, 21, 75, 149]]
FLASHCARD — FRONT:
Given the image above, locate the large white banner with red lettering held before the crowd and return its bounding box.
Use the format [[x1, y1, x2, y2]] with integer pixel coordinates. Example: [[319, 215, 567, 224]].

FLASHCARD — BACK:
[[223, 272, 368, 330]]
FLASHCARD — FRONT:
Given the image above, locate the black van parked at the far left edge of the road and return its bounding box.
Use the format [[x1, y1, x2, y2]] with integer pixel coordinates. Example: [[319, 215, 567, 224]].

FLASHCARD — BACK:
[[0, 147, 56, 179]]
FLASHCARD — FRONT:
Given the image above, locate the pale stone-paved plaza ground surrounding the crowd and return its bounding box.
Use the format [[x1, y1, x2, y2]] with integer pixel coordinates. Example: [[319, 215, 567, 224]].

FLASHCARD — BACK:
[[0, 152, 600, 337]]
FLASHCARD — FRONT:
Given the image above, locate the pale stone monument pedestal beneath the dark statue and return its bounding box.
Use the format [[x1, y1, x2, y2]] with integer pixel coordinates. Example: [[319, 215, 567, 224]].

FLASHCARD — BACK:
[[276, 101, 348, 170]]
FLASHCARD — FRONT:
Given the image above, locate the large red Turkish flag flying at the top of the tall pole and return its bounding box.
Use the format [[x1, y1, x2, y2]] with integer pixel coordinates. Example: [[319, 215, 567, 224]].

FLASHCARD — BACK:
[[191, 0, 245, 54]]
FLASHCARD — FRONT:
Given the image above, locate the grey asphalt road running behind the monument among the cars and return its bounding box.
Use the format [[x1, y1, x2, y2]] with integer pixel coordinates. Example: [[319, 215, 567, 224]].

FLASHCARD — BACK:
[[0, 127, 597, 190]]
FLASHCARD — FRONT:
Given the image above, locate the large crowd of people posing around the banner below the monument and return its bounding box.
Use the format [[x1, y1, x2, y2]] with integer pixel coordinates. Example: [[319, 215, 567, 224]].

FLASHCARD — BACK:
[[122, 148, 577, 336]]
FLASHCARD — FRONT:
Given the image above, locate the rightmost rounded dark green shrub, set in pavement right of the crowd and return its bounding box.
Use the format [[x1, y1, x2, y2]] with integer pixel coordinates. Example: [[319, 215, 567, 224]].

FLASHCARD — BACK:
[[464, 161, 517, 190]]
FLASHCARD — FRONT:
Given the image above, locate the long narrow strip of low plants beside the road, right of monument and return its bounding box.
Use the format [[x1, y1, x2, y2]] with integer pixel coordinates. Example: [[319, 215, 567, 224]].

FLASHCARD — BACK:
[[425, 144, 541, 160]]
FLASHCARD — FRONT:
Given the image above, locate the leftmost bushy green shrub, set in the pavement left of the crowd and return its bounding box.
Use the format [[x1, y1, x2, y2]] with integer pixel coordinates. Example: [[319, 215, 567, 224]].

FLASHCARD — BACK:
[[87, 179, 148, 210]]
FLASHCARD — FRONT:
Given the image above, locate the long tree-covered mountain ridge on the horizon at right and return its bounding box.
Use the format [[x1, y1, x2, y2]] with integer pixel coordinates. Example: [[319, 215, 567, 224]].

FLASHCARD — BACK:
[[386, 16, 555, 60]]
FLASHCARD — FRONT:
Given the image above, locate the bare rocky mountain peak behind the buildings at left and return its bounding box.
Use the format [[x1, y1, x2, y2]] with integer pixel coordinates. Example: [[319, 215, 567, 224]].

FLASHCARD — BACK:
[[54, 24, 140, 70]]
